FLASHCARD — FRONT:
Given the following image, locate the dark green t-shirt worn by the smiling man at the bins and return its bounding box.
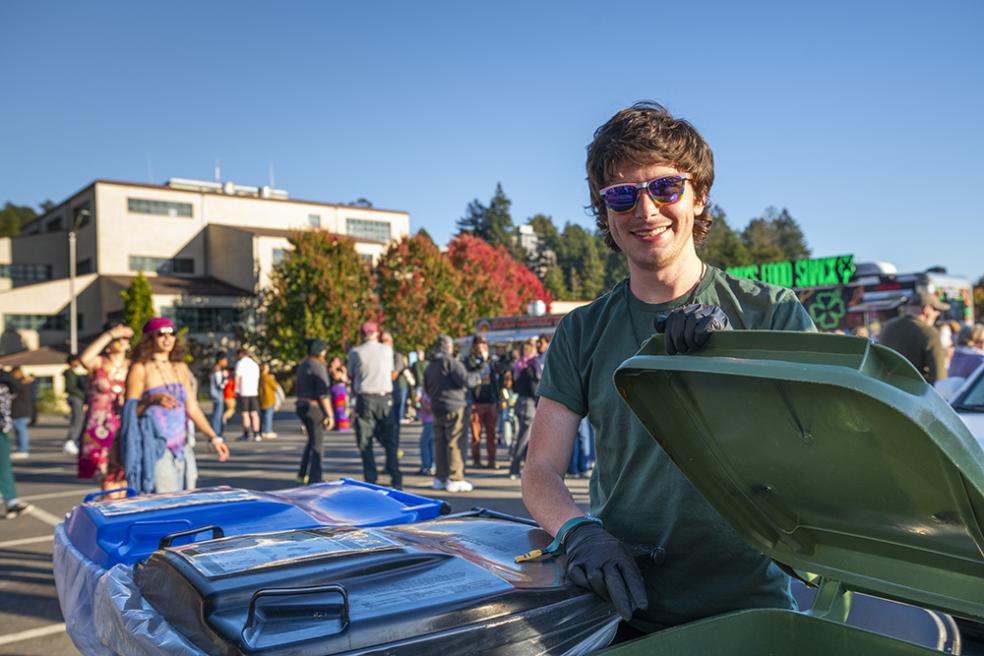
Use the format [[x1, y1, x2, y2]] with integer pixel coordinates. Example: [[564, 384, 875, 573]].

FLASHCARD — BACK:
[[540, 267, 815, 631]]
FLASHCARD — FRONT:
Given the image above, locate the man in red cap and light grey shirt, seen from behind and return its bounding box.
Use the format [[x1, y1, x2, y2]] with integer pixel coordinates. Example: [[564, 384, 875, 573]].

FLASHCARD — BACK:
[[348, 321, 403, 490]]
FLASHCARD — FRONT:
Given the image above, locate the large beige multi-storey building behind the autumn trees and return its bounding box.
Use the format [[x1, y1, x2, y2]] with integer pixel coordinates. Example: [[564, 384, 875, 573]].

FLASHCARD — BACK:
[[0, 178, 410, 382]]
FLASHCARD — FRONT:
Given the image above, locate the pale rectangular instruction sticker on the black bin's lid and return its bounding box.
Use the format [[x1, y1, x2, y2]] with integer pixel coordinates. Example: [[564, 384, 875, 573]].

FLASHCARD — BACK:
[[173, 530, 402, 577]]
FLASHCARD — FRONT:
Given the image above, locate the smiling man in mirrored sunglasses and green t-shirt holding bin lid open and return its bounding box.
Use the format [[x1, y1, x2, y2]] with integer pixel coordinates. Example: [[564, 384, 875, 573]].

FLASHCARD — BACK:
[[523, 103, 814, 635]]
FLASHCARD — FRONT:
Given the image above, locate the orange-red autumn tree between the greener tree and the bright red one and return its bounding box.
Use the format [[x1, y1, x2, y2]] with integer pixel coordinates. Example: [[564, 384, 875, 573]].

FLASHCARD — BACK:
[[376, 232, 472, 353]]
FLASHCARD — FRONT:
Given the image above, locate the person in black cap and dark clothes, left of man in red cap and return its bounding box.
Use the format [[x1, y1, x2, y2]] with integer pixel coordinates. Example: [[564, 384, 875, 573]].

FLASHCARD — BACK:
[[294, 339, 335, 485]]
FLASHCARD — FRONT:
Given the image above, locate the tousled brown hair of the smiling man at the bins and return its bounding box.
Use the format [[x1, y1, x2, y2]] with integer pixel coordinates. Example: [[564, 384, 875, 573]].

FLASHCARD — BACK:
[[587, 101, 714, 251]]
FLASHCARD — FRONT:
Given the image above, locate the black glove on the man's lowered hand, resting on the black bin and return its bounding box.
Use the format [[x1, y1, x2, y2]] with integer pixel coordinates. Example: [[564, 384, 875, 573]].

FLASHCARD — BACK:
[[564, 523, 649, 621]]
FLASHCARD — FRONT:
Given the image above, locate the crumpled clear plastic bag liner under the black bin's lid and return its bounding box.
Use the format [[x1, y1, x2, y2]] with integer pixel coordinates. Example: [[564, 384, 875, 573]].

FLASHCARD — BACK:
[[93, 565, 207, 656]]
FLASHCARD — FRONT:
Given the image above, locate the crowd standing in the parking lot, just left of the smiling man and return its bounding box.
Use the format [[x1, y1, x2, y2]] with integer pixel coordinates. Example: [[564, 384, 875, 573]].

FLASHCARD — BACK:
[[294, 321, 580, 492]]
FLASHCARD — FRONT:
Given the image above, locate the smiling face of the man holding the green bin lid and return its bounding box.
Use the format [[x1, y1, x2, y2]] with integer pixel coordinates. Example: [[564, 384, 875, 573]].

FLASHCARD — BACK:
[[607, 164, 704, 271]]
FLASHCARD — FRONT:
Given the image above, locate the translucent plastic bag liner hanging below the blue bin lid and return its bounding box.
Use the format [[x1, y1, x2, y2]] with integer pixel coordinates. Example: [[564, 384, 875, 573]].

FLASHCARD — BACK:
[[52, 523, 114, 656]]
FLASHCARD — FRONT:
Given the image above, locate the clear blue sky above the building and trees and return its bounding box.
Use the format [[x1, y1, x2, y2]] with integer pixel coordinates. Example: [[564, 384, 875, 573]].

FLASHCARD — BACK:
[[0, 0, 984, 279]]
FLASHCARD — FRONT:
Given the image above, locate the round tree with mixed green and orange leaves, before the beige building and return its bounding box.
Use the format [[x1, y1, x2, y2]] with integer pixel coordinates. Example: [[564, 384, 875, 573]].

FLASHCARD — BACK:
[[254, 230, 380, 362]]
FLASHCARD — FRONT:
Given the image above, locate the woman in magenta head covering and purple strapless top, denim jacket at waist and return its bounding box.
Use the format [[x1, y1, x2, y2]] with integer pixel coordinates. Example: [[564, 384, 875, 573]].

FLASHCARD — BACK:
[[125, 317, 229, 492]]
